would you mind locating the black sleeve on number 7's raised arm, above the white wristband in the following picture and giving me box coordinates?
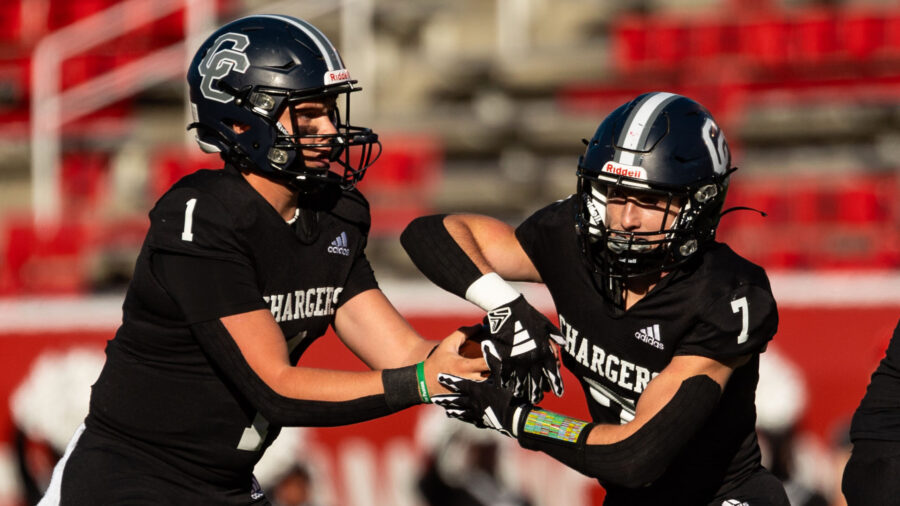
[400,214,481,298]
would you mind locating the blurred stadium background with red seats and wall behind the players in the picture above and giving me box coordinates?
[0,0,900,505]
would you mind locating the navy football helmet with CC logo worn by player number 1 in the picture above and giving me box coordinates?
[187,15,381,189]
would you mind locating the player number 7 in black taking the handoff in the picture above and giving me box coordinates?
[401,92,788,506]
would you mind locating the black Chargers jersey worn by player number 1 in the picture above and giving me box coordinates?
[86,167,377,486]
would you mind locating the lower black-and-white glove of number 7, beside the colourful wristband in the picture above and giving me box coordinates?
[431,373,532,437]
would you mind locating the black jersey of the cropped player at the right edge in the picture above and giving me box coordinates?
[850,321,900,441]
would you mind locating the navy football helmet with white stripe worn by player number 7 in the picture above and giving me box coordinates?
[577,92,736,280]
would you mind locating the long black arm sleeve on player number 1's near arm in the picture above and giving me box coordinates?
[191,320,419,427]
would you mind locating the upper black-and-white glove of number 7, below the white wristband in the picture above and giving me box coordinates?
[481,295,565,404]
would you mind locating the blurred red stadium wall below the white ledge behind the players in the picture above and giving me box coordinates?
[0,304,900,504]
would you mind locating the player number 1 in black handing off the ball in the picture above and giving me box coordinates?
[42,15,487,505]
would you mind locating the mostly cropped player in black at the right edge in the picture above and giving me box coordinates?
[841,321,900,506]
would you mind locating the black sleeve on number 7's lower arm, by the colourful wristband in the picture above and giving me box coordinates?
[519,375,721,488]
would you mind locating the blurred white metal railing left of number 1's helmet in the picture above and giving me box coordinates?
[31,0,215,229]
